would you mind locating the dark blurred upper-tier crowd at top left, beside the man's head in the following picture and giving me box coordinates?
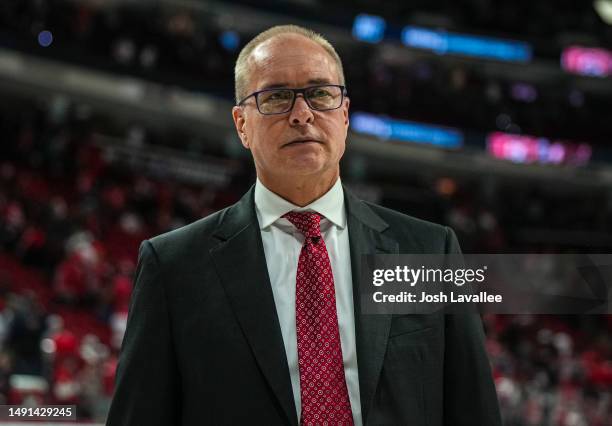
[0,0,240,96]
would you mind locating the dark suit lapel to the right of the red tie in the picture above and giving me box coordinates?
[344,188,399,425]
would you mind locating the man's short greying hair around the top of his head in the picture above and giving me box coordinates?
[234,25,345,103]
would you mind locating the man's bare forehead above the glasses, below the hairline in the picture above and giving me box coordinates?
[250,34,339,90]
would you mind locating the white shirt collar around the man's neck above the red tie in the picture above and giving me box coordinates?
[255,177,346,229]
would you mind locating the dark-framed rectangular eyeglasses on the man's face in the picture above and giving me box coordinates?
[238,84,347,115]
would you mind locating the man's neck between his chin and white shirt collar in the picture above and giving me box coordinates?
[257,170,340,207]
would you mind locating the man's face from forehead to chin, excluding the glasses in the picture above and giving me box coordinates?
[232,34,349,185]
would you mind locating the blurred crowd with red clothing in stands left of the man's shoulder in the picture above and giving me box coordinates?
[0,93,238,420]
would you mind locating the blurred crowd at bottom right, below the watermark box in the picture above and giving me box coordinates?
[484,314,612,426]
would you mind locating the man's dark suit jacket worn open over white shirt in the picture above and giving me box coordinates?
[107,187,501,426]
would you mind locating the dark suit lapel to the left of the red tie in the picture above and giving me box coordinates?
[210,187,298,426]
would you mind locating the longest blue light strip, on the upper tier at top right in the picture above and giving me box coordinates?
[402,26,533,62]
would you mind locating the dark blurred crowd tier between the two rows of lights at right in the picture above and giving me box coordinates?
[344,55,612,148]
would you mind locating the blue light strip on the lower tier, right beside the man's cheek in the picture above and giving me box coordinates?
[351,112,463,148]
